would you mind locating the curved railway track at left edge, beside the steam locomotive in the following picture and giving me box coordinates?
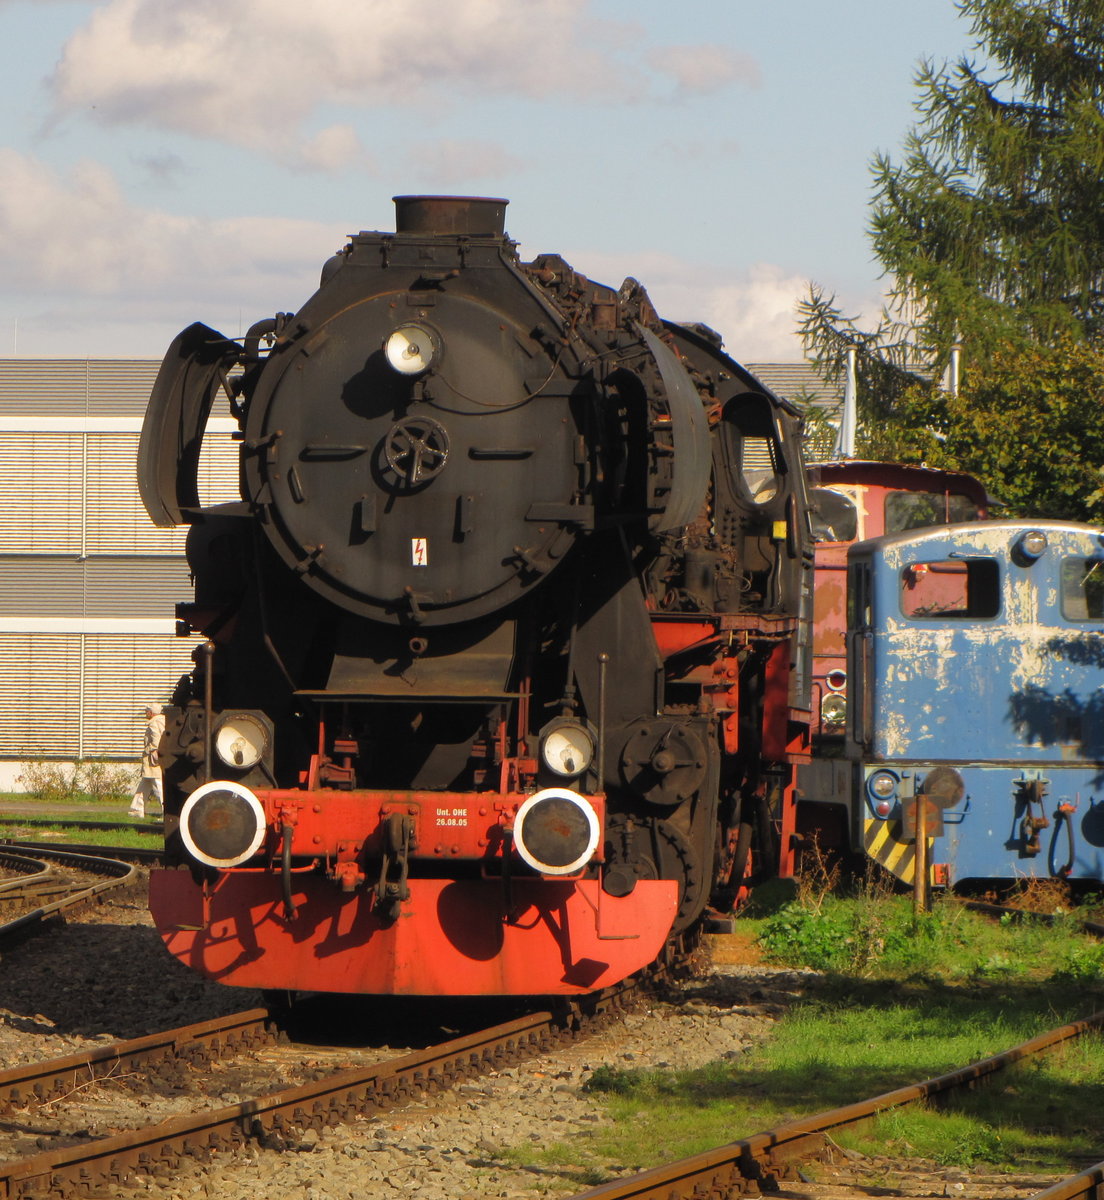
[0,842,138,947]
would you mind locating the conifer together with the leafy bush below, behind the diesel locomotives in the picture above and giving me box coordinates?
[800,0,1104,521]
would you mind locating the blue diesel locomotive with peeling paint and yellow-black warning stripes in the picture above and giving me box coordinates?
[823,521,1104,886]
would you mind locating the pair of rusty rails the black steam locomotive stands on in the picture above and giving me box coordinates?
[0,980,650,1200]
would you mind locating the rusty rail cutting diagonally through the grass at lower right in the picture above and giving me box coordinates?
[564,1012,1104,1200]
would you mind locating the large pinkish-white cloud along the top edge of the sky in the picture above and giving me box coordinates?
[52,0,751,154]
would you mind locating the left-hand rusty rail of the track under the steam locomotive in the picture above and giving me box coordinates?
[0,1008,275,1112]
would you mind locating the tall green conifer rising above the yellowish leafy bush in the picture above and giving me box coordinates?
[871,0,1104,356]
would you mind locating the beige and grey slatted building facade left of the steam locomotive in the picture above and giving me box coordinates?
[0,359,238,760]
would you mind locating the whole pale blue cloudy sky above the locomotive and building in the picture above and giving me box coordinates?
[0,0,971,362]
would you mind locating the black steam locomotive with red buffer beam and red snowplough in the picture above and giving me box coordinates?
[139,197,811,995]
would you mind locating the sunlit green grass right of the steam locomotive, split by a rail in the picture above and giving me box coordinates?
[502,892,1104,1190]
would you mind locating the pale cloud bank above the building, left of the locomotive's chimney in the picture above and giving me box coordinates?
[0,148,343,354]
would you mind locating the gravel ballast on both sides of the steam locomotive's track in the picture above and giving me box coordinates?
[0,873,811,1200]
